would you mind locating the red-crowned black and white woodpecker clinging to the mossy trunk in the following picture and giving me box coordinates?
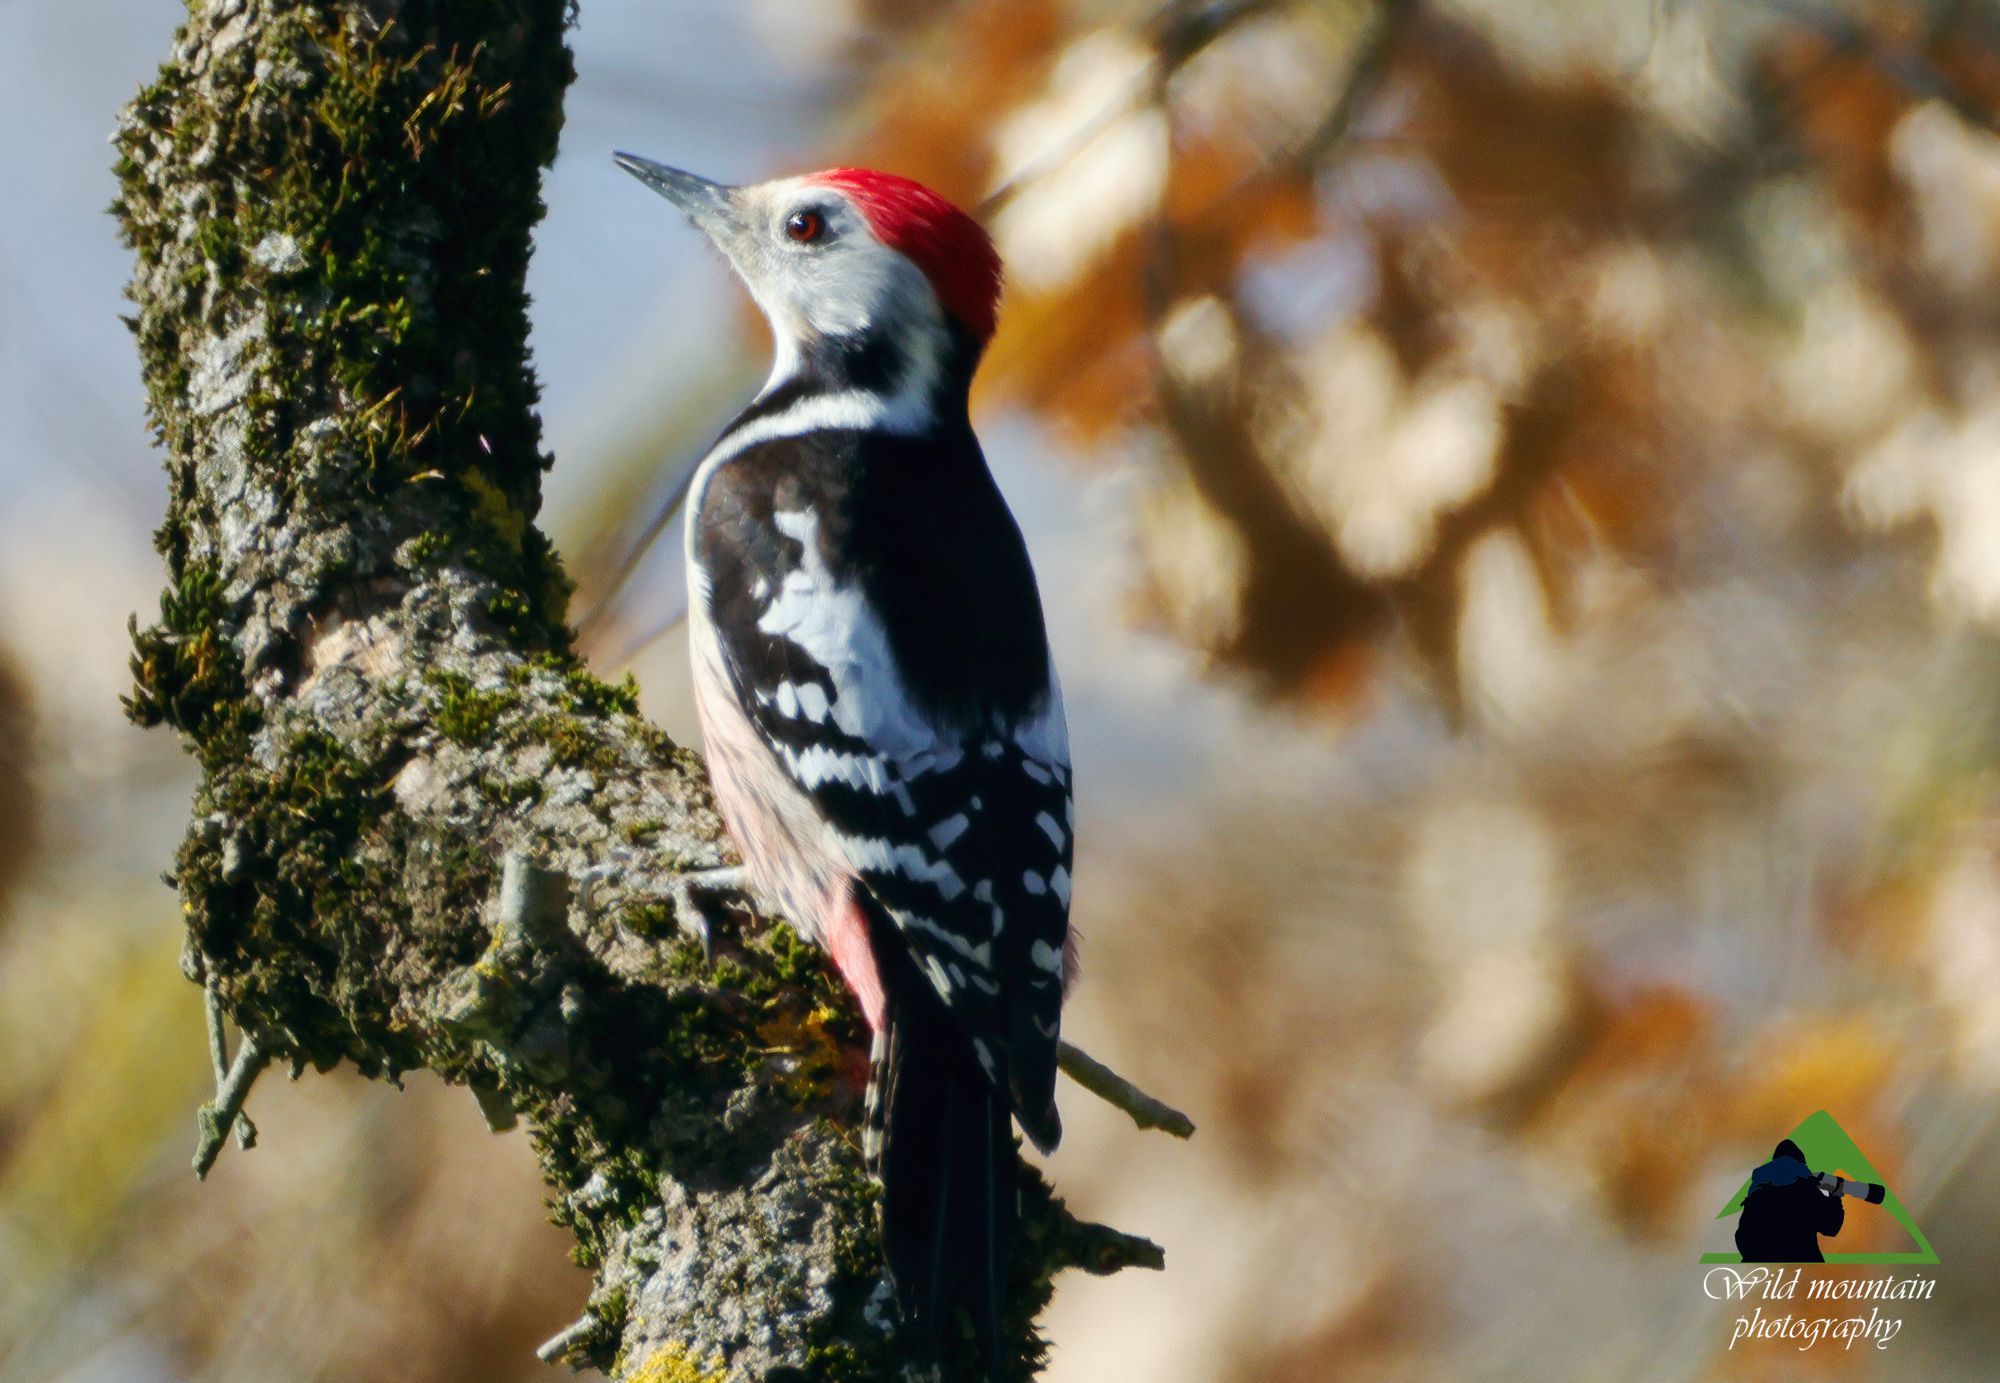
[616,154,1076,1379]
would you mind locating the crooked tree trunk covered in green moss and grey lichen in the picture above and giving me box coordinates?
[116,0,1156,1383]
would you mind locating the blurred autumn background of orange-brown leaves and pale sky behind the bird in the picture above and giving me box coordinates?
[0,0,2000,1383]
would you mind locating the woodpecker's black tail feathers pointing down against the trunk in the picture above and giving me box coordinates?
[870,991,1020,1383]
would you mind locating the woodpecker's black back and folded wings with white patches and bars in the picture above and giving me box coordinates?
[692,428,1074,1147]
